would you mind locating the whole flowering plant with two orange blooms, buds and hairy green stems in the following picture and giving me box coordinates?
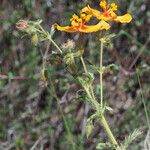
[16,0,142,150]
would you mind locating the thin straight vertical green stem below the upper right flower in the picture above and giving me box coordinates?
[100,41,103,108]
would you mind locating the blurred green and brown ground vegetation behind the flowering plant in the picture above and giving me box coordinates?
[0,0,150,150]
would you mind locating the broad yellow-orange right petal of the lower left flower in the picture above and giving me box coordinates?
[79,20,110,33]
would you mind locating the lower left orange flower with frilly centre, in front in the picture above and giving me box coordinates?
[54,13,110,33]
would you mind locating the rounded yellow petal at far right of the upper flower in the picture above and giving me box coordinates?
[114,14,132,23]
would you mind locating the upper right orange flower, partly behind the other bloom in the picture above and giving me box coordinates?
[81,0,132,23]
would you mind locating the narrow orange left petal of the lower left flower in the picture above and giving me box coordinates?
[53,24,78,32]
